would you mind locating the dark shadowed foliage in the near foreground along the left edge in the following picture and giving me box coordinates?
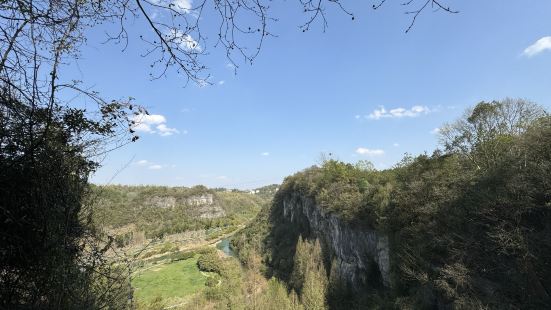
[0,83,135,309]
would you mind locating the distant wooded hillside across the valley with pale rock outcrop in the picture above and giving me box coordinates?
[92,185,269,243]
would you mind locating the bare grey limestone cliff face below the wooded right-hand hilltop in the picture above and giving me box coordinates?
[283,194,391,287]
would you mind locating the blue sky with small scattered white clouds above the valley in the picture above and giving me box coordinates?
[77,0,551,188]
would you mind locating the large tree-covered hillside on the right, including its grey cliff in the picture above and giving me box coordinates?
[233,99,551,309]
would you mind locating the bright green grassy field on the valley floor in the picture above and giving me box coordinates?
[132,257,207,303]
